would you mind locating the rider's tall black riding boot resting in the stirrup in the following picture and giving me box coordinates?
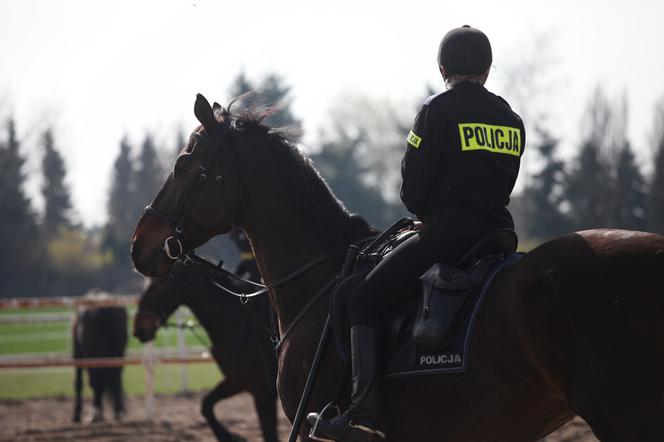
[307,325,385,442]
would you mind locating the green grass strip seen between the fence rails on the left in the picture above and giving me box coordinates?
[0,308,221,399]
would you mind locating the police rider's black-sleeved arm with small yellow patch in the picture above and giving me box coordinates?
[401,103,443,219]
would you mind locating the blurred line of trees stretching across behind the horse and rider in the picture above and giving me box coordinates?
[0,73,664,297]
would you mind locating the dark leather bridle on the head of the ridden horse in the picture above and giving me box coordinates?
[143,117,231,261]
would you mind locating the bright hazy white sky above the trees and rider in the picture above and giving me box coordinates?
[0,0,664,225]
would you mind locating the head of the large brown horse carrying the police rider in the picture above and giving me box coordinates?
[131,94,240,276]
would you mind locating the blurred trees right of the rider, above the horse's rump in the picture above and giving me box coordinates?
[519,87,664,241]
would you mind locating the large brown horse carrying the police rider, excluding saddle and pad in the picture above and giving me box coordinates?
[131,94,664,442]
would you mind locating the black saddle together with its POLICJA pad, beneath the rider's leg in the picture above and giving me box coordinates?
[331,219,520,378]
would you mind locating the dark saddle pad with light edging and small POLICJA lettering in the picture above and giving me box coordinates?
[384,254,523,379]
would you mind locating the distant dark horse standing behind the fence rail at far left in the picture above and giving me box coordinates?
[72,307,127,422]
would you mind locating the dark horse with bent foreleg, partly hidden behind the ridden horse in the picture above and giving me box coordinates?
[134,261,279,442]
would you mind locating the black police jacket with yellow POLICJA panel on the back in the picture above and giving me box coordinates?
[401,83,526,235]
